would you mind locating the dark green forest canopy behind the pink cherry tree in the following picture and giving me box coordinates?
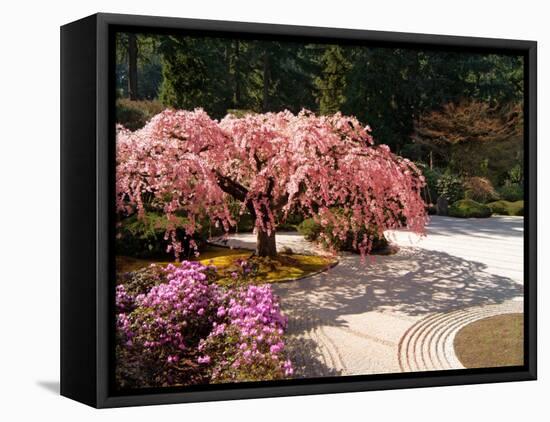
[117,33,523,159]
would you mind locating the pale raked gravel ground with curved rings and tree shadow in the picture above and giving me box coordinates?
[211,216,523,377]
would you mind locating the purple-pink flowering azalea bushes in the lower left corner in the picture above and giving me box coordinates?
[116,261,292,387]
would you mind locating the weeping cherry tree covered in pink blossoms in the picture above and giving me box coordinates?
[116,109,427,257]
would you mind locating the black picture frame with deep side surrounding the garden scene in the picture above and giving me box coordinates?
[61,13,537,408]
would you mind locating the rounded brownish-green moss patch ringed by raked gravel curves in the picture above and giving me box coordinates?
[454,314,524,368]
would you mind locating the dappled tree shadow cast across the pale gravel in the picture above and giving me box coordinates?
[274,247,523,330]
